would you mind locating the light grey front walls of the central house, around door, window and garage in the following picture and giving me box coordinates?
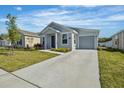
[41,32,98,50]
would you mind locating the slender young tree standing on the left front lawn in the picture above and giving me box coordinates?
[6,14,20,54]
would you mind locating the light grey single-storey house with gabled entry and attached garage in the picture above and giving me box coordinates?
[40,22,99,49]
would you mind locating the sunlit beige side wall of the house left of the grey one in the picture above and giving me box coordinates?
[23,36,40,47]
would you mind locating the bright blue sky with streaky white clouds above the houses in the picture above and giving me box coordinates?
[0,5,124,37]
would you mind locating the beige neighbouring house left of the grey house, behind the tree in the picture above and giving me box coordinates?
[17,30,40,48]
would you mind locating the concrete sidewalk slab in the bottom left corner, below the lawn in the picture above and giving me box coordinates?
[0,69,36,88]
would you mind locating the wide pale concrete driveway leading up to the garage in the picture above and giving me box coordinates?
[13,50,100,88]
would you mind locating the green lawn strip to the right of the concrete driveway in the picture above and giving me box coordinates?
[98,50,124,88]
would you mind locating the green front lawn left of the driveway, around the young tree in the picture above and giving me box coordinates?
[0,49,57,72]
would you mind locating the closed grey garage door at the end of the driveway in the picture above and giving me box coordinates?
[79,36,95,49]
